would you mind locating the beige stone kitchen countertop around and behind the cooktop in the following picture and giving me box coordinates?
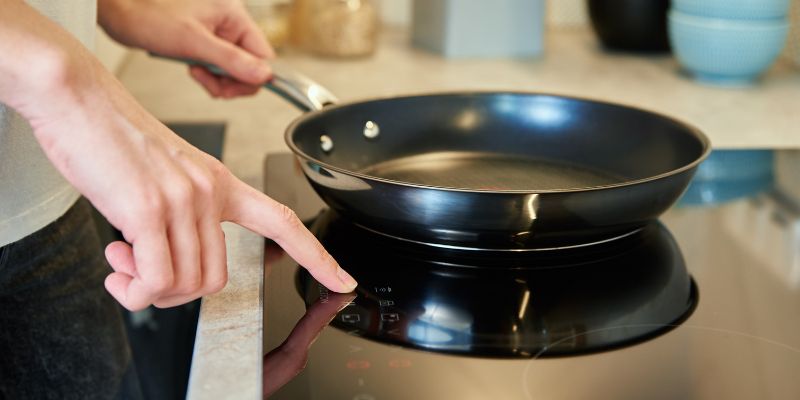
[114,29,800,399]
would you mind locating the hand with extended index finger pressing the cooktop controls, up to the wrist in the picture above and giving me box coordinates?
[55,69,354,309]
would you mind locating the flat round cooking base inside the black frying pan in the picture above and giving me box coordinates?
[359,152,626,191]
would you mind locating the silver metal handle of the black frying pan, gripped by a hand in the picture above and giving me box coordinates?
[150,53,339,111]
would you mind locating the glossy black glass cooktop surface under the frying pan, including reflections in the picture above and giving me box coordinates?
[263,151,800,400]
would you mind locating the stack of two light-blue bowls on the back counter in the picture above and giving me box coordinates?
[668,0,789,86]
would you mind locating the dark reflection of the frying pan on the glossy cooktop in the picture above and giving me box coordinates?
[298,214,698,357]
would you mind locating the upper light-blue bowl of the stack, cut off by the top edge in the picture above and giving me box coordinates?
[672,0,789,19]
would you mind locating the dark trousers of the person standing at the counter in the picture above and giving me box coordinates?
[0,199,141,399]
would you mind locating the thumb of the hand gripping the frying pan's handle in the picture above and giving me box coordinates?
[192,30,272,85]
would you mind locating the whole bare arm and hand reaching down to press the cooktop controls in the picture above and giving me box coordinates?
[0,0,355,310]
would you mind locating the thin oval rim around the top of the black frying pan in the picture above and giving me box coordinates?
[284,90,712,194]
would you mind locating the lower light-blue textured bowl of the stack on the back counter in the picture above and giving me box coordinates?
[668,10,789,86]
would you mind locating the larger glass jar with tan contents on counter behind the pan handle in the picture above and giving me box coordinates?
[305,0,380,57]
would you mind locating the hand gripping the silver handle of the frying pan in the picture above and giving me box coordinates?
[98,0,275,98]
